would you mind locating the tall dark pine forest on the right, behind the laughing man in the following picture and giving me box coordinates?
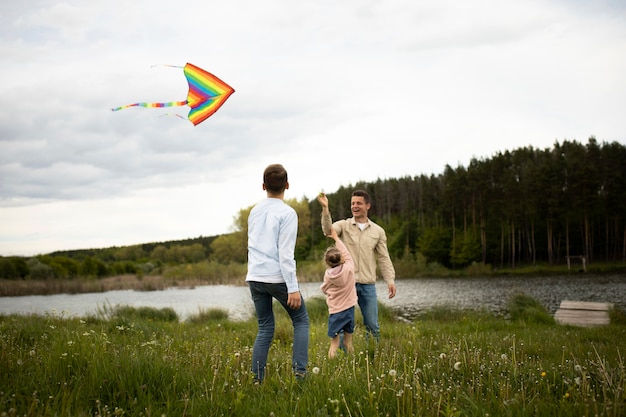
[316,137,626,268]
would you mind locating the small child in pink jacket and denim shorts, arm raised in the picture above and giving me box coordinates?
[320,208,357,359]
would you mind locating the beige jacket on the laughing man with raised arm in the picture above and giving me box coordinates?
[322,211,396,284]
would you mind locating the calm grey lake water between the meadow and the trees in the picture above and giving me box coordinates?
[0,274,626,319]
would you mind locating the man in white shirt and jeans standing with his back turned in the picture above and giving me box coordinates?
[246,164,309,384]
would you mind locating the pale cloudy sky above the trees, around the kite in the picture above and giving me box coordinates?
[0,0,626,256]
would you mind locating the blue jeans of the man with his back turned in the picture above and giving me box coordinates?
[248,281,309,381]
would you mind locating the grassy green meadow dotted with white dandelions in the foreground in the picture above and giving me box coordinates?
[0,294,626,417]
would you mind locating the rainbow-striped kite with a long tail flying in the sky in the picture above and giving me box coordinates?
[111,63,235,126]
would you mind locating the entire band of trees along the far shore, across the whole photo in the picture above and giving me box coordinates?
[0,137,626,279]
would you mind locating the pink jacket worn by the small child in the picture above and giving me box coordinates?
[320,240,357,314]
